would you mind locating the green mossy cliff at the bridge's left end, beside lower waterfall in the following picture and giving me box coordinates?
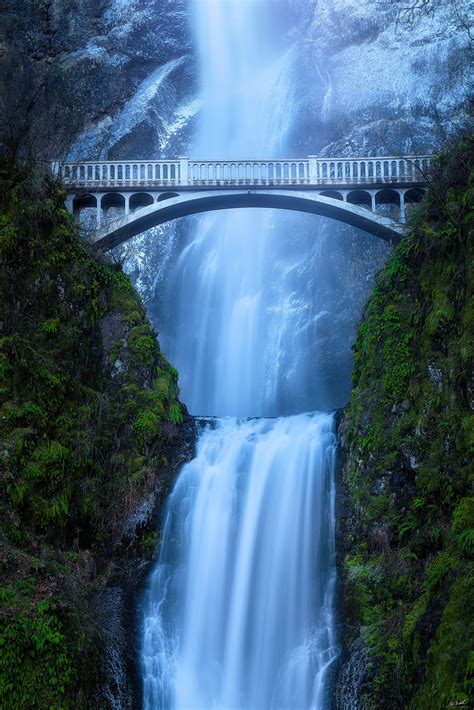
[0,164,183,710]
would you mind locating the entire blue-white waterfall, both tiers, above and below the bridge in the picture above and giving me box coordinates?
[141,0,337,710]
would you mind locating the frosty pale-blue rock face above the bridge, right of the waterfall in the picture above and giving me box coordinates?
[286,0,470,155]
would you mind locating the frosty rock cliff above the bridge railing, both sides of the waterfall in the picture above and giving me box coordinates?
[0,0,469,159]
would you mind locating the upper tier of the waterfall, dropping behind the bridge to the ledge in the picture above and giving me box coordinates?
[159,0,318,416]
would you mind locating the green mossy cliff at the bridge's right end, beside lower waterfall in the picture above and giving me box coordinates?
[338,140,474,710]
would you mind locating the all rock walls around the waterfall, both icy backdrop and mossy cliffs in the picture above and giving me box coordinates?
[0,0,473,710]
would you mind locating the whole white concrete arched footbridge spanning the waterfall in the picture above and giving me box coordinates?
[52,156,431,250]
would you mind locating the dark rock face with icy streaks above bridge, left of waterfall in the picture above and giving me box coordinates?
[0,0,197,159]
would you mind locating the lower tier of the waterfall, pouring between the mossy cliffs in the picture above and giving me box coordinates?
[141,413,337,710]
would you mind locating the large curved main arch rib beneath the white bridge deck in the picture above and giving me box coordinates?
[93,189,403,250]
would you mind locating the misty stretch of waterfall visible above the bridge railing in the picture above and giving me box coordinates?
[191,0,292,158]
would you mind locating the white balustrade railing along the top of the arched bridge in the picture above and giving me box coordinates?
[52,155,431,189]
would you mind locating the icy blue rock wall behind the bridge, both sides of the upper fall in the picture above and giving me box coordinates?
[0,0,469,407]
